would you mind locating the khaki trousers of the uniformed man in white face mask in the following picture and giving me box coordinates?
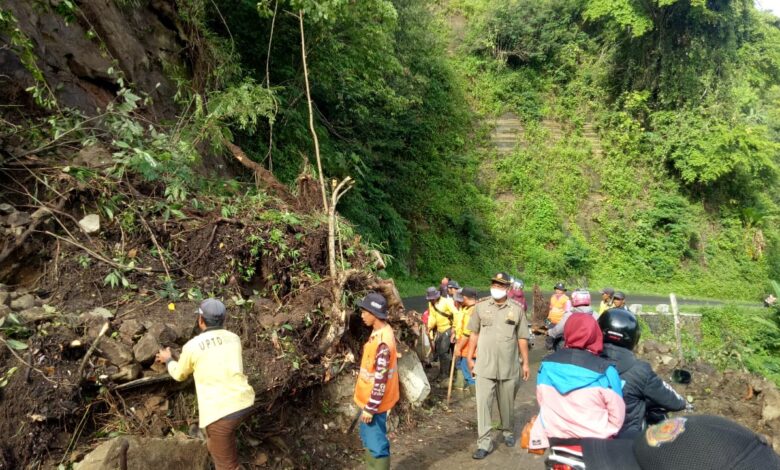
[477,375,517,452]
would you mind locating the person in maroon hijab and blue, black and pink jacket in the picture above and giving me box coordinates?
[529,313,626,449]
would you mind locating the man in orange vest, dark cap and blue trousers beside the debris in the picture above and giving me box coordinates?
[355,292,400,470]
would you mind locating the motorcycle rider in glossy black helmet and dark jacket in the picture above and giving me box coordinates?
[598,308,691,438]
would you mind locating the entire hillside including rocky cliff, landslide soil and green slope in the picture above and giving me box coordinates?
[0,0,780,469]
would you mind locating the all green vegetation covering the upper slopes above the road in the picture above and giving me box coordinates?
[0,0,780,299]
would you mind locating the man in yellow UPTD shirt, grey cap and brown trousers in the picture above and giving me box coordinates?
[157,299,255,470]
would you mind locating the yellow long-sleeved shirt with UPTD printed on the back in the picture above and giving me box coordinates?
[168,328,255,428]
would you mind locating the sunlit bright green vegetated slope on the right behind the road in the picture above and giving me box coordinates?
[442,0,780,299]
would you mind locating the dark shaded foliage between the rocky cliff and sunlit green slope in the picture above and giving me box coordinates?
[201,0,494,282]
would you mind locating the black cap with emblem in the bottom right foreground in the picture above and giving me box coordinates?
[582,415,780,470]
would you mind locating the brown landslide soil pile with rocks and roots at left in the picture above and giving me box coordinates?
[0,149,414,469]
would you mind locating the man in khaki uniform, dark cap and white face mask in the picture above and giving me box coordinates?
[466,273,530,460]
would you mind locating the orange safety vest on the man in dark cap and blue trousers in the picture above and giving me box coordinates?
[355,325,400,413]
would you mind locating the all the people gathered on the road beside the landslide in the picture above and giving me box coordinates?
[152,273,780,470]
